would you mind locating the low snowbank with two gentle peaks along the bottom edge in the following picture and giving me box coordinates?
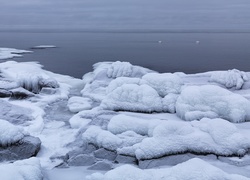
[87,158,249,180]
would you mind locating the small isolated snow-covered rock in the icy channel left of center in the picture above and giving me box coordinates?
[67,96,92,113]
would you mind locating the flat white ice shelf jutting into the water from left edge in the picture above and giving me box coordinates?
[0,48,32,60]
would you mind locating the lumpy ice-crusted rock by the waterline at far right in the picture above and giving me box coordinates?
[209,69,248,90]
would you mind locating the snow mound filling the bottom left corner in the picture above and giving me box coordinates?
[0,158,43,180]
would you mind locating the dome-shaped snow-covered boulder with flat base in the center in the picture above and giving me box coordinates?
[101,84,162,113]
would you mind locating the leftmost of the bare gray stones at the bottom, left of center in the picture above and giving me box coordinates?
[68,154,96,166]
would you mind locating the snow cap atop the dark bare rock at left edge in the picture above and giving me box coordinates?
[0,119,25,146]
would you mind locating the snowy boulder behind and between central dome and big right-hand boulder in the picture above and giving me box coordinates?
[142,73,183,97]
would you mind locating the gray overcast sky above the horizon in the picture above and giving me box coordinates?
[0,0,250,30]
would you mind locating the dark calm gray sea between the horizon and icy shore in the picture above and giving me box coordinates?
[0,32,250,77]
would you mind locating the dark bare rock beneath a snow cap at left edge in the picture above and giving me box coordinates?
[0,136,41,162]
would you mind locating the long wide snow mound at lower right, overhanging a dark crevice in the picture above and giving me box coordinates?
[118,118,249,160]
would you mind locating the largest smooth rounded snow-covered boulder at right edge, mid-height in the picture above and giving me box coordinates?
[176,85,250,122]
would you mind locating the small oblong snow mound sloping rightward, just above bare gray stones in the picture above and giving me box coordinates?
[82,126,122,150]
